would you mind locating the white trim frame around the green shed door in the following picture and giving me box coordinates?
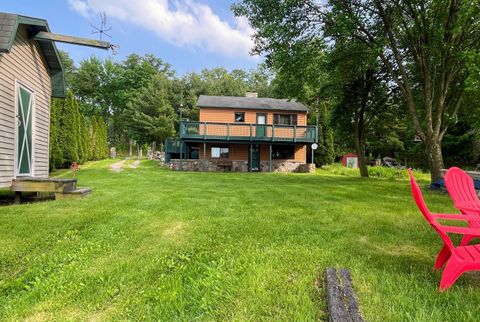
[13,78,36,179]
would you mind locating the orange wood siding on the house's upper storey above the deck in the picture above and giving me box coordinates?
[200,107,307,125]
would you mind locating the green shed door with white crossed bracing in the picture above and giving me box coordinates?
[15,84,33,176]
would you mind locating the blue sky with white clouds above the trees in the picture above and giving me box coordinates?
[0,0,261,74]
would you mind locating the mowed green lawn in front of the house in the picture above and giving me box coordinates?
[0,161,480,321]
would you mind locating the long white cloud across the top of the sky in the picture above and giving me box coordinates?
[69,0,253,57]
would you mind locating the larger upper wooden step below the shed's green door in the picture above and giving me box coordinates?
[11,177,77,193]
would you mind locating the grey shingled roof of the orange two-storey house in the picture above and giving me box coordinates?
[197,95,308,112]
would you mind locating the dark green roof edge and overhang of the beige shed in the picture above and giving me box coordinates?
[0,12,66,97]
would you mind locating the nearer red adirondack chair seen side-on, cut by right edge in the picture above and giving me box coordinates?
[408,169,480,291]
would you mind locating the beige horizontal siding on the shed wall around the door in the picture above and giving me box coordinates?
[0,25,51,187]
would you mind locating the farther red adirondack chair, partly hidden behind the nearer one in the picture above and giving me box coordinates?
[444,167,480,246]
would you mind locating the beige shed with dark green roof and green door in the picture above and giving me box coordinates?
[0,13,65,187]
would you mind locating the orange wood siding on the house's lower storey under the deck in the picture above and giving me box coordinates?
[199,143,307,163]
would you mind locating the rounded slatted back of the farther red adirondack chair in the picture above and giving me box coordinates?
[445,167,478,204]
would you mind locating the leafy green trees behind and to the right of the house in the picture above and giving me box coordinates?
[54,9,480,180]
